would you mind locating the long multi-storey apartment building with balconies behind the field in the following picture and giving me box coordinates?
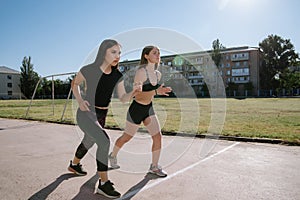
[120,46,261,96]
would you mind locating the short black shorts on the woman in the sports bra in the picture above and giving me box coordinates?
[127,100,155,124]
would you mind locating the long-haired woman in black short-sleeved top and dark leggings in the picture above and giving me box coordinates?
[68,39,141,198]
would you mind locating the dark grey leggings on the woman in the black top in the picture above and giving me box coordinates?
[75,109,110,171]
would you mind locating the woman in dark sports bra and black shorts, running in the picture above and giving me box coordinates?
[109,46,172,177]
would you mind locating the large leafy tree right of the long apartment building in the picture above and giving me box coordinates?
[259,35,299,89]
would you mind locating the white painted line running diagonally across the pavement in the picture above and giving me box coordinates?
[120,142,240,199]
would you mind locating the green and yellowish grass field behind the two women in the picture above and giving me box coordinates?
[0,98,300,144]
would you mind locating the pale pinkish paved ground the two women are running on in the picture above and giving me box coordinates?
[0,119,300,200]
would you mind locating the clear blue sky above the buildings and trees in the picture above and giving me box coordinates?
[0,0,300,76]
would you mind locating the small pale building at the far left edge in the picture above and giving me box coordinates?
[0,66,21,99]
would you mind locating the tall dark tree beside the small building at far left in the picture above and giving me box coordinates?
[20,56,39,98]
